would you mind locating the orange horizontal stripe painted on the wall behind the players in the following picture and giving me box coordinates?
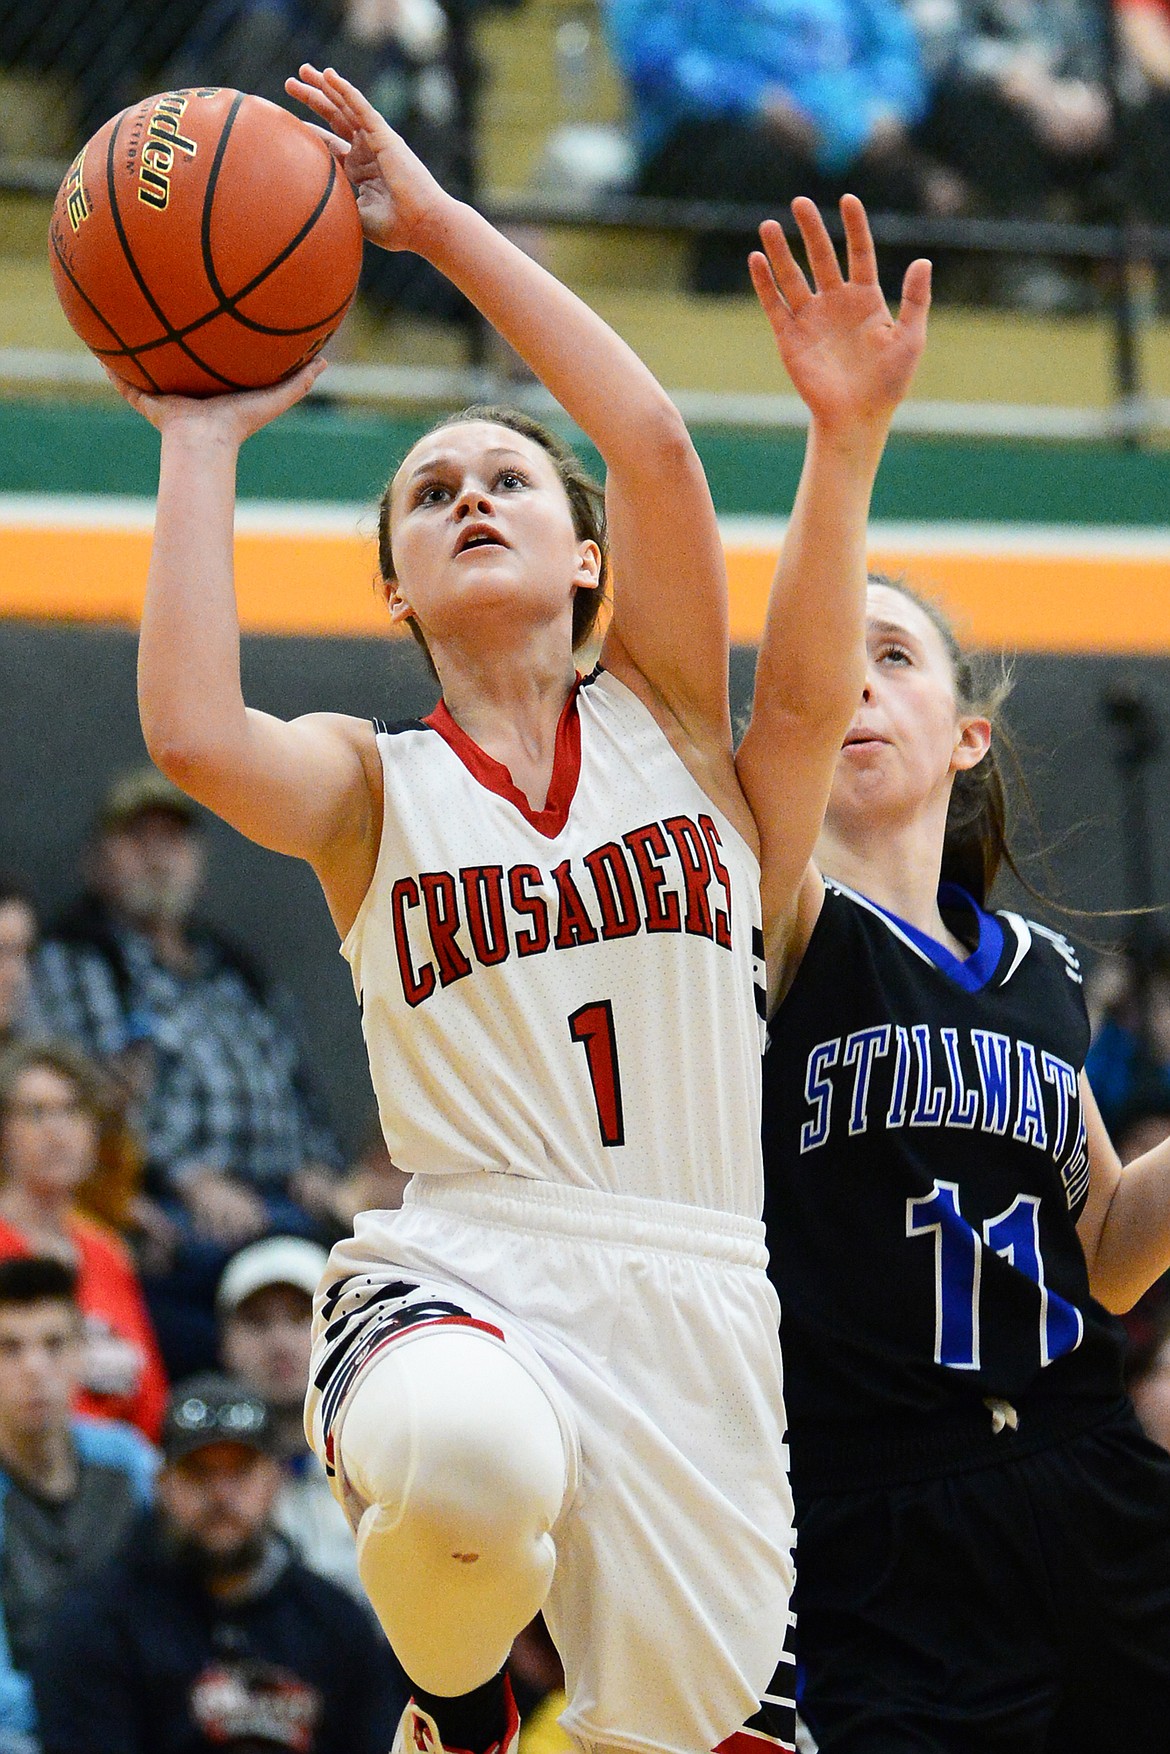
[0,524,1170,654]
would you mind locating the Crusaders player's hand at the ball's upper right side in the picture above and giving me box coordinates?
[284,61,451,256]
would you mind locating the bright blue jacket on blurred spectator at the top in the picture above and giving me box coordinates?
[603,0,926,172]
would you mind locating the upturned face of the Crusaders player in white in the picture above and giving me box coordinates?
[389,421,600,651]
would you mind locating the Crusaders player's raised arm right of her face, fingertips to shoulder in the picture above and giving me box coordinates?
[288,67,733,764]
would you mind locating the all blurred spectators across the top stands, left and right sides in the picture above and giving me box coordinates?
[0,0,1170,321]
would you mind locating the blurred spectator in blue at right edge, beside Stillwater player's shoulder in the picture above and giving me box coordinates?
[1084,938,1170,1138]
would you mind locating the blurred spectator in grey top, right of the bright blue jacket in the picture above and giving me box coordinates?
[907,0,1110,307]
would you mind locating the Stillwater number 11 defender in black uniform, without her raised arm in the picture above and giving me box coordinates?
[749,582,1170,1754]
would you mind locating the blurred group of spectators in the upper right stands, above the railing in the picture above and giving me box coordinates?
[603,0,1170,305]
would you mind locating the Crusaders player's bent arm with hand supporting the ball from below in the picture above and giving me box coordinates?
[114,361,379,924]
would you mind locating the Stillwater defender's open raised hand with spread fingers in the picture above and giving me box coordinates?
[749,195,930,438]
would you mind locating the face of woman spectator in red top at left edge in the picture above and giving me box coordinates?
[0,1065,98,1203]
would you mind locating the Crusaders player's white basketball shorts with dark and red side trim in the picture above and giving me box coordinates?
[305,1173,793,1754]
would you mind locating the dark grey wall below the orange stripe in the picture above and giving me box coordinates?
[0,623,1170,1147]
